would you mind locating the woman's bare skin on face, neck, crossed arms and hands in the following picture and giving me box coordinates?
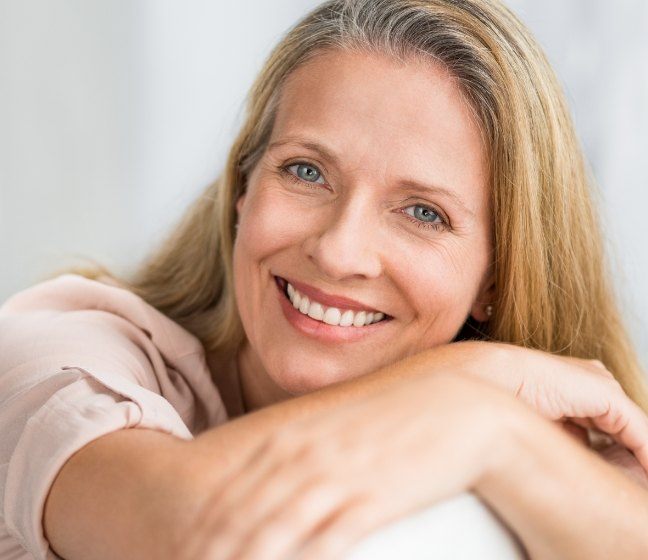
[38,53,648,560]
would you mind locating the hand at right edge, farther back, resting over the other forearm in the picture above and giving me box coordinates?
[454,342,648,472]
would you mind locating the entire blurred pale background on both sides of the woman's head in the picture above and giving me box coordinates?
[0,0,648,365]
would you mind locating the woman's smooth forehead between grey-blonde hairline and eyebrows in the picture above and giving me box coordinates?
[270,51,486,209]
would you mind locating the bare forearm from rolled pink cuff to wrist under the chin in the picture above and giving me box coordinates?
[43,343,477,560]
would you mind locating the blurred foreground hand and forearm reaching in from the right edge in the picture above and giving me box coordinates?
[189,372,648,560]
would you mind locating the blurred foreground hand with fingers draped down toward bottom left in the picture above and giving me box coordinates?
[175,373,524,560]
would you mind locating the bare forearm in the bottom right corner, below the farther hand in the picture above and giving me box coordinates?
[476,403,648,560]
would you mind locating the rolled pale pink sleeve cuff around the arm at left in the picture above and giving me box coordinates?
[4,366,193,560]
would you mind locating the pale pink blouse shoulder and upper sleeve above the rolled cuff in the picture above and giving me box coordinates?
[0,274,230,430]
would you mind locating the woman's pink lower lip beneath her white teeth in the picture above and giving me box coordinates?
[274,277,391,342]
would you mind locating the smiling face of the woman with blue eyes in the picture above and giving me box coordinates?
[234,51,492,395]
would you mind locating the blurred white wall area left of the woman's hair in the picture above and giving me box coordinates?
[0,0,315,301]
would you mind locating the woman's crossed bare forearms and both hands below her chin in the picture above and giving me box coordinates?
[43,342,648,560]
